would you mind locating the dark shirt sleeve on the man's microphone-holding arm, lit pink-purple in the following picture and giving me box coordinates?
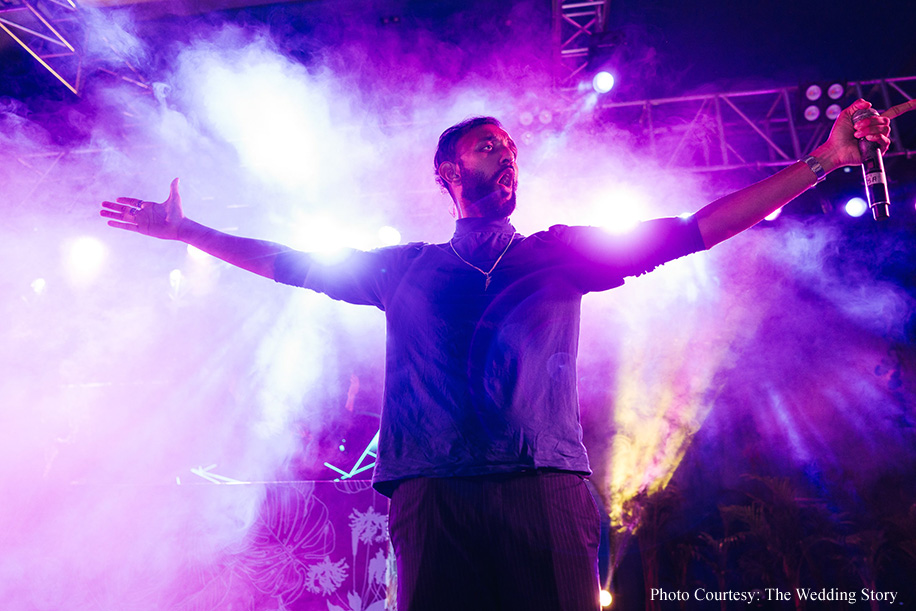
[550,216,706,291]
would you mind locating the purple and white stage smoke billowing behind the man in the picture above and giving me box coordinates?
[0,2,913,609]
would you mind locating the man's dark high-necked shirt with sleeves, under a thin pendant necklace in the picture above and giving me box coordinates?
[275,218,704,495]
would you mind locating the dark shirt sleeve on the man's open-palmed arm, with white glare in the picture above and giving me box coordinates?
[274,245,416,310]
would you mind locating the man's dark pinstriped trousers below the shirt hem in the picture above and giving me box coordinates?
[388,472,599,611]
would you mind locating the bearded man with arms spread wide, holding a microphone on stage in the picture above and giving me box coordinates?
[102,100,899,610]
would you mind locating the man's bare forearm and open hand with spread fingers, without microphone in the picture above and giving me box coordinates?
[101,178,285,279]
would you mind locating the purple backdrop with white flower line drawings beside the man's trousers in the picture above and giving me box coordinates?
[164,480,394,611]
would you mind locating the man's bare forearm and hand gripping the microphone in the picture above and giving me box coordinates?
[696,100,900,248]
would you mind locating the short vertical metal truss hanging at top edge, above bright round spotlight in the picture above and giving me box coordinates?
[552,0,611,89]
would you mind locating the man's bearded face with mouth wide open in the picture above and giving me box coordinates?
[455,125,518,218]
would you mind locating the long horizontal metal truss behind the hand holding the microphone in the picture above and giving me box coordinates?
[598,76,916,171]
